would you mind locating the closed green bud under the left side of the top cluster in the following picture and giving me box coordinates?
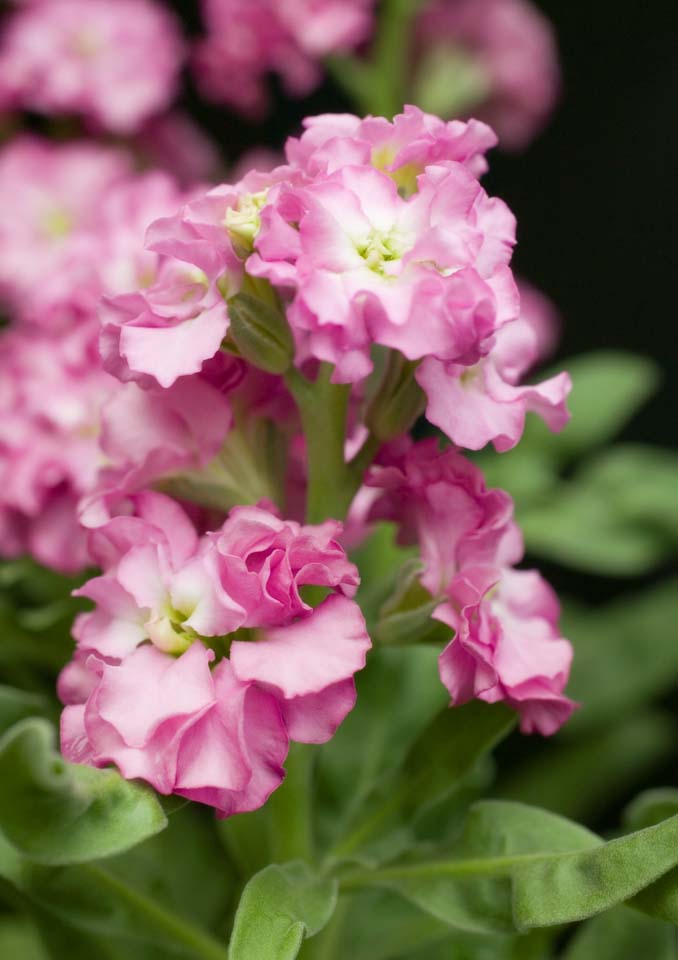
[228,293,294,374]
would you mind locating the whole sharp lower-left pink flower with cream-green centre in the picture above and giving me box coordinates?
[60,493,370,816]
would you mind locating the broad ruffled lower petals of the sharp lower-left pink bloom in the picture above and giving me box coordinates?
[61,643,289,817]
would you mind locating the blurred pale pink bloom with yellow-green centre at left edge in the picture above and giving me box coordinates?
[0,136,131,327]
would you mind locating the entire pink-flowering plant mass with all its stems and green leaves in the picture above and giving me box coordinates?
[0,0,678,960]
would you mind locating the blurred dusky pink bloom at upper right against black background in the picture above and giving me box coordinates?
[417,0,560,150]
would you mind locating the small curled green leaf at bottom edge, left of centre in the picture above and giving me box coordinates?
[228,862,337,960]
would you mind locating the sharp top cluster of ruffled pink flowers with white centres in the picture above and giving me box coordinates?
[103,107,570,450]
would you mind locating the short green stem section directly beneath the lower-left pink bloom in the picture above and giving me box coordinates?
[268,743,315,863]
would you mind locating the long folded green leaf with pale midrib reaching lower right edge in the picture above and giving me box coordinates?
[343,801,678,933]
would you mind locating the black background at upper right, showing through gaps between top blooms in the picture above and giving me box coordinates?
[174,0,678,450]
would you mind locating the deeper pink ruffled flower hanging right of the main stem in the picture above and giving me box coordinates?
[368,441,575,735]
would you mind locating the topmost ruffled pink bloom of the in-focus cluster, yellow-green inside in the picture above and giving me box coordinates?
[285,106,497,184]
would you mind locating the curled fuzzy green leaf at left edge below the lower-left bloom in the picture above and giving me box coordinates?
[0,719,167,864]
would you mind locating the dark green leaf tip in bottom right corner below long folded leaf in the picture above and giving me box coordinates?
[563,907,676,960]
